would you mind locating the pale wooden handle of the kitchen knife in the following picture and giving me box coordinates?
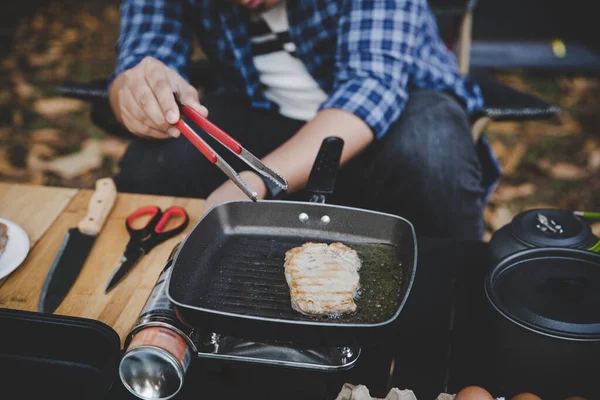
[77,178,117,236]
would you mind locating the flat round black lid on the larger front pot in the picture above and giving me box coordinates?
[486,248,600,340]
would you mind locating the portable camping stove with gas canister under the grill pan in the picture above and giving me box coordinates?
[119,250,361,399]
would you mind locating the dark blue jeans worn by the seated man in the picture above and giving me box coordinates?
[115,90,485,239]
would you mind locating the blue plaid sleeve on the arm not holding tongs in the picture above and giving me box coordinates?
[321,0,427,138]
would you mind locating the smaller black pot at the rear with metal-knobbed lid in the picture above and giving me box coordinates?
[490,208,600,262]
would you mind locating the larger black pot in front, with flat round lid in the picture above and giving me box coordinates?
[485,248,600,400]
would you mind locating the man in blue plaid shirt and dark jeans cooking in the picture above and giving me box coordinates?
[109,0,492,239]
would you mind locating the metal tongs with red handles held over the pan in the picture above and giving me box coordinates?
[175,96,288,201]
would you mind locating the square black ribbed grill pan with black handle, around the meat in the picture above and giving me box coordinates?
[169,139,416,347]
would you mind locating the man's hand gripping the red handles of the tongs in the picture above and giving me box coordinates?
[109,57,208,139]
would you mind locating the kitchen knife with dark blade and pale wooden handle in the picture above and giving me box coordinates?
[38,178,117,314]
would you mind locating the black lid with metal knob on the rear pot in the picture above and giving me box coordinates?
[512,209,595,247]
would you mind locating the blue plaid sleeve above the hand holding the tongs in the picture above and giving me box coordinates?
[110,0,192,81]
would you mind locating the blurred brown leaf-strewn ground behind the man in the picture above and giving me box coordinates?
[0,0,600,237]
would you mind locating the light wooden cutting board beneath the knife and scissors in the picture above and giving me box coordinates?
[0,185,204,341]
